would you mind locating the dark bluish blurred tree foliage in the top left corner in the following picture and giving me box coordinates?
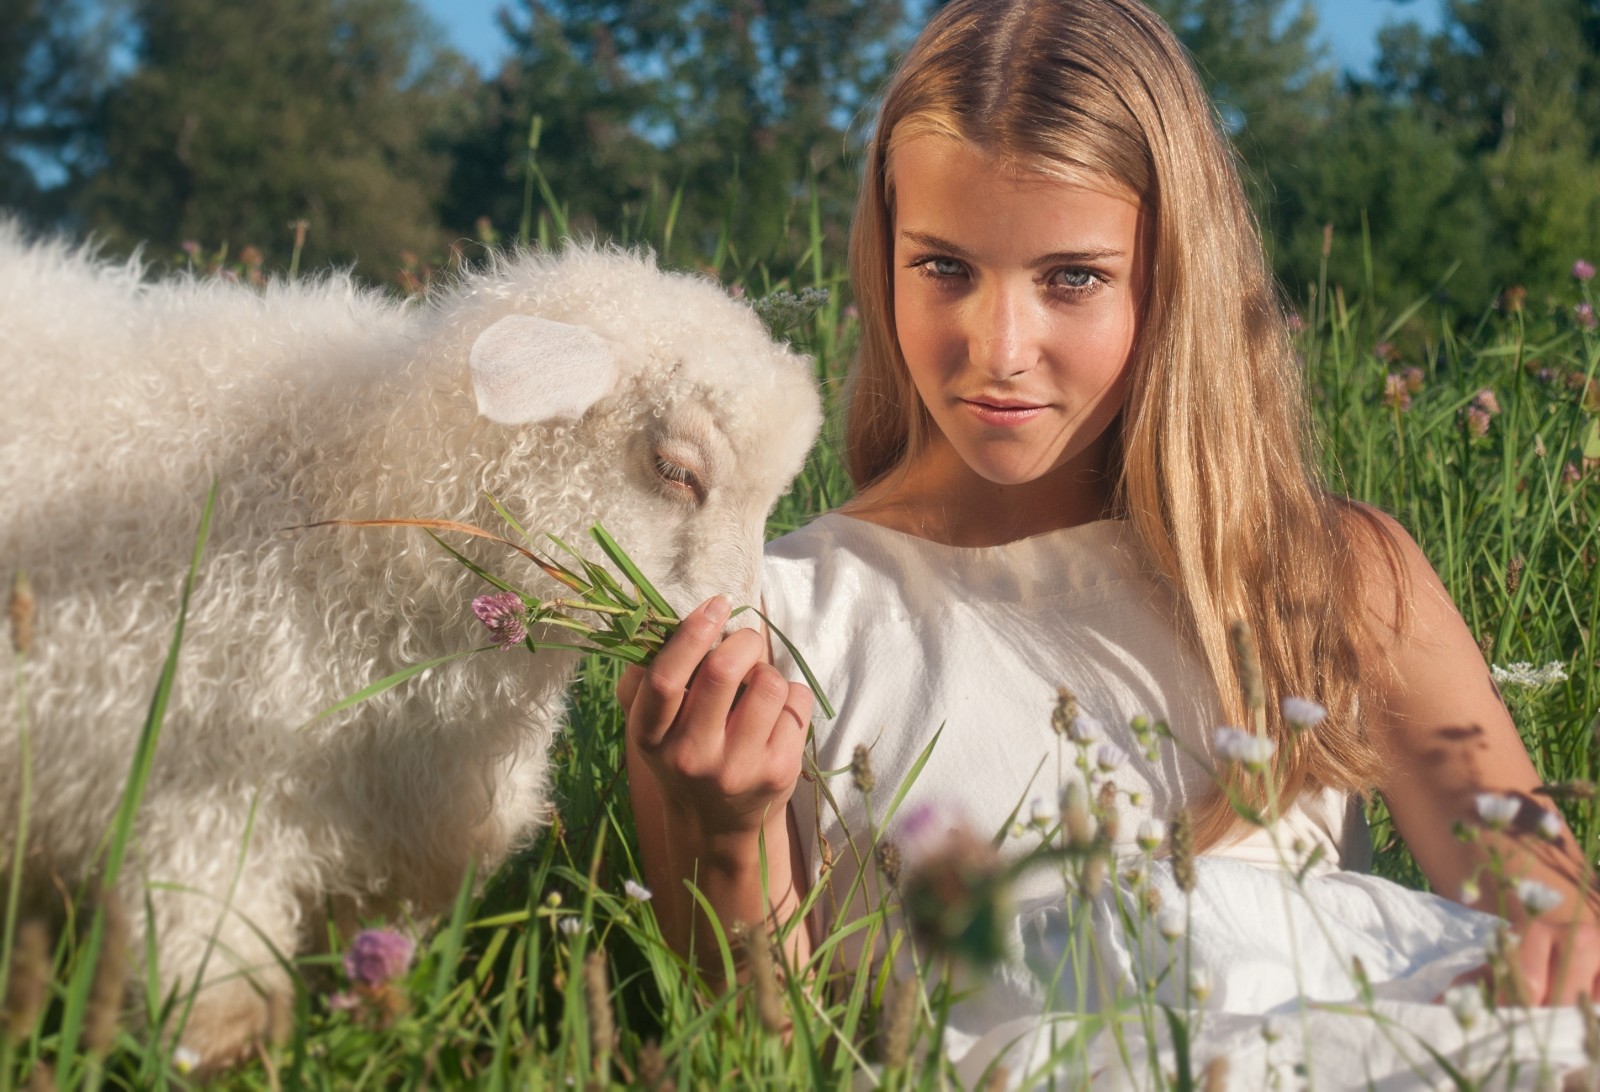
[0,0,110,223]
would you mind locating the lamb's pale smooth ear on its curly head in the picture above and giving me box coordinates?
[470,315,619,424]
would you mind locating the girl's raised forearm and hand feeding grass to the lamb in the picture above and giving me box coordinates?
[618,597,811,974]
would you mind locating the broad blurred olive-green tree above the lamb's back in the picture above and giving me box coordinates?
[83,0,470,275]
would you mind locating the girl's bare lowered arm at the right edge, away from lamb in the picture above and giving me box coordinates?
[1366,516,1600,1004]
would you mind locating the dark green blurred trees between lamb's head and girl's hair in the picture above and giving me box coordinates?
[451,0,910,267]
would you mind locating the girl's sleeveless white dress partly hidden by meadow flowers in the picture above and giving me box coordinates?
[763,514,1584,1089]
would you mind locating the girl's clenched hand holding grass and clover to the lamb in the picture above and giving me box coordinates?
[618,596,813,850]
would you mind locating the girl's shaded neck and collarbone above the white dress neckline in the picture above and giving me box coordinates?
[842,425,1112,546]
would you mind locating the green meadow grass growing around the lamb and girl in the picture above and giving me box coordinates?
[0,222,1600,1092]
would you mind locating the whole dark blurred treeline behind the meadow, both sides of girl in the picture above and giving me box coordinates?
[0,0,1600,312]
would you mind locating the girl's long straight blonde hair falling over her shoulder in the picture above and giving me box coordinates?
[845,0,1387,847]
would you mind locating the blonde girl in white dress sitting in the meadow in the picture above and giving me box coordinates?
[621,0,1600,1087]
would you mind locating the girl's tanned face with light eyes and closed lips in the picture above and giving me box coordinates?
[893,134,1147,487]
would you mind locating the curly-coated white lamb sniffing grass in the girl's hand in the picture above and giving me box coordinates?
[0,223,821,1065]
